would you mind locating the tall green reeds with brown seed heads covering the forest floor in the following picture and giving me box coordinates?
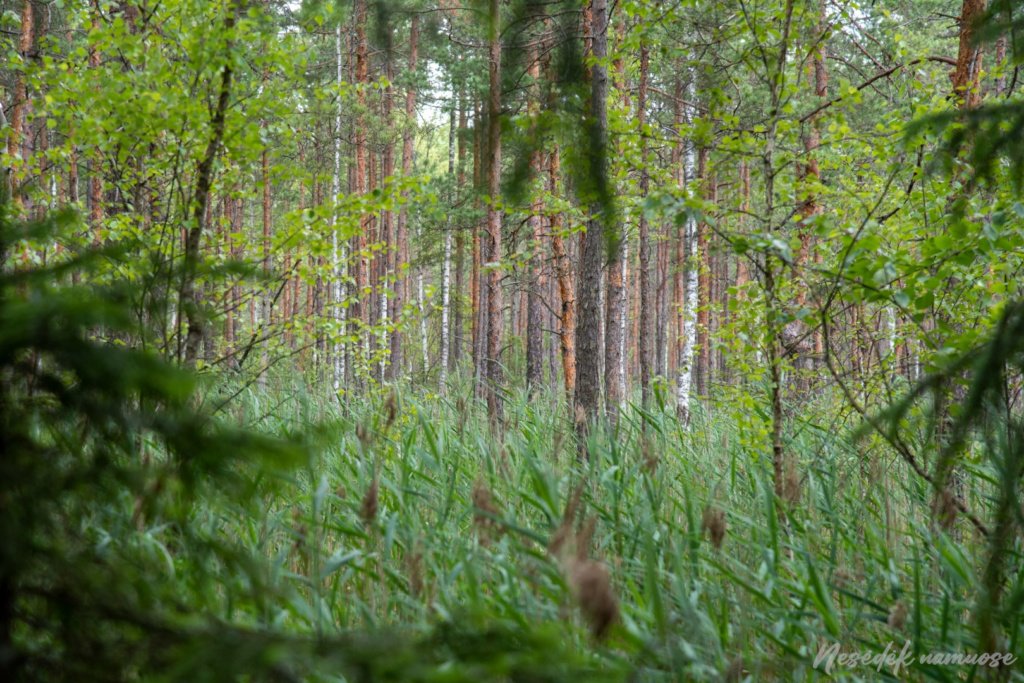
[188,370,1024,681]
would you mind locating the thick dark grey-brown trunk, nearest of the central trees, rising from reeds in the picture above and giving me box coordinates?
[574,0,608,444]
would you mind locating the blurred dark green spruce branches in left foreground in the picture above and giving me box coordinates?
[0,206,614,681]
